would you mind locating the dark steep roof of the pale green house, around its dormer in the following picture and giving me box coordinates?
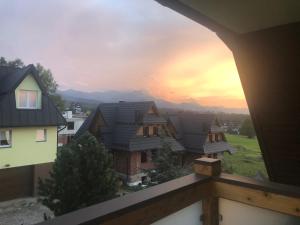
[0,65,66,127]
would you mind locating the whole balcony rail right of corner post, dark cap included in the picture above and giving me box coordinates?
[213,174,300,217]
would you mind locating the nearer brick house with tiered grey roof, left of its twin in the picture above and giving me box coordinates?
[76,101,184,184]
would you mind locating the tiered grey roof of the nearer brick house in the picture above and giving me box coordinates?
[76,101,183,151]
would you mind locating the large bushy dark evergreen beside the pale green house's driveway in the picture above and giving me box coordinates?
[39,133,117,215]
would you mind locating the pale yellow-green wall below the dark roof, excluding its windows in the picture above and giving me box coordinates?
[0,127,57,169]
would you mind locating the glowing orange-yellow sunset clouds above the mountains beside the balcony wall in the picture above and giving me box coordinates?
[149,43,247,108]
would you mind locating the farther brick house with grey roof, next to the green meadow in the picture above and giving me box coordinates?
[167,111,235,163]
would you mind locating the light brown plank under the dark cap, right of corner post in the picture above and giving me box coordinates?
[213,182,300,217]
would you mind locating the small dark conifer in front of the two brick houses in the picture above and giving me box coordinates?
[145,140,190,184]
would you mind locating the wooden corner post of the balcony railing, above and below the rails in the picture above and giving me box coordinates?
[194,158,221,225]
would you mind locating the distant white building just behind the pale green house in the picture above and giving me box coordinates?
[58,111,87,146]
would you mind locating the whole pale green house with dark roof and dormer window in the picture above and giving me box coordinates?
[0,65,65,200]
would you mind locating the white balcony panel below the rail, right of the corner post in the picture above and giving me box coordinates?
[219,199,300,225]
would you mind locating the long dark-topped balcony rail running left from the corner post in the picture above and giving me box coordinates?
[36,174,212,225]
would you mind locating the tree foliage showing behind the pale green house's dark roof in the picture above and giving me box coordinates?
[0,57,65,111]
